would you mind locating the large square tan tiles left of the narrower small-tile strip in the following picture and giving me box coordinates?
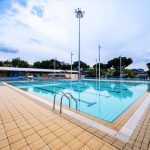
[0,86,116,150]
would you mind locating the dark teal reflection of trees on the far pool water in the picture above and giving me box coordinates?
[22,81,150,99]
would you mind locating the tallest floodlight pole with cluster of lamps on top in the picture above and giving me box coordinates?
[75,8,85,79]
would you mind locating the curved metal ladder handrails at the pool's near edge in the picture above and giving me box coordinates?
[53,91,77,113]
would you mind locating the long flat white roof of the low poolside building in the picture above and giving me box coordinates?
[0,67,77,73]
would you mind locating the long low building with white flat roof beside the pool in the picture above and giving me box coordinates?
[0,67,78,80]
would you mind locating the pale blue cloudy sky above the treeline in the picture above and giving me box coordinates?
[0,0,150,69]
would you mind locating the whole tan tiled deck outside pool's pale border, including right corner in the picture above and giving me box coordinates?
[0,86,150,150]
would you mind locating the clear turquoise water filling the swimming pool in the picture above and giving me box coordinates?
[9,80,149,122]
